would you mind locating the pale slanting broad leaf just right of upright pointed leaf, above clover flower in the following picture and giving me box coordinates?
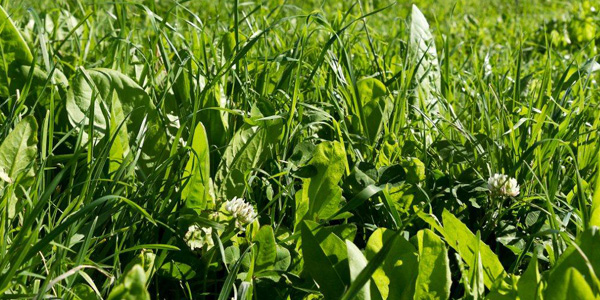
[215,123,281,199]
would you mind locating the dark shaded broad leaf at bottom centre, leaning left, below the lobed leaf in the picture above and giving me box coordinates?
[300,222,346,299]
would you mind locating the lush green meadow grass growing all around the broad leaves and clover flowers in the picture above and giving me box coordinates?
[0,0,600,299]
